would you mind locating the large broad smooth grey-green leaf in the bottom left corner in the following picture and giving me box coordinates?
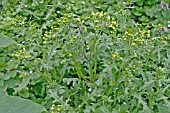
[0,92,46,113]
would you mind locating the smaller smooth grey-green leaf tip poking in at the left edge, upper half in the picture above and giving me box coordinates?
[0,34,15,47]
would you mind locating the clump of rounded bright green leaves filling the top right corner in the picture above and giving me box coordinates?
[130,0,170,26]
